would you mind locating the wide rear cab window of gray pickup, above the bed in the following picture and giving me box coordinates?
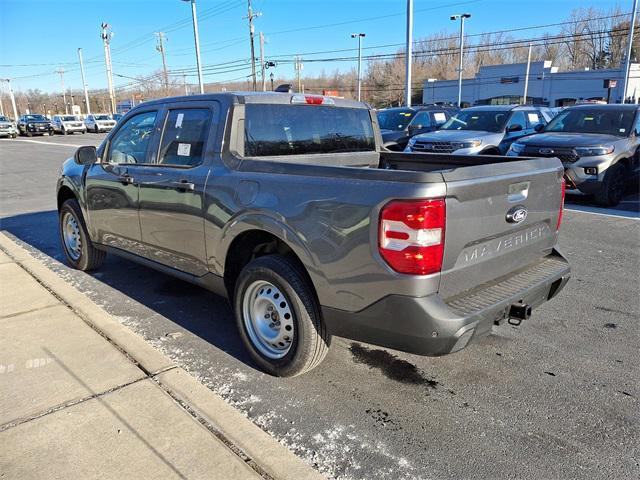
[244,104,375,157]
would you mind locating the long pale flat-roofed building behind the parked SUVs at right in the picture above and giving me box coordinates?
[422,60,640,107]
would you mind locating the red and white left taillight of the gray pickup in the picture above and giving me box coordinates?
[378,198,446,275]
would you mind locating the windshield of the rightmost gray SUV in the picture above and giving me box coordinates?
[544,108,636,137]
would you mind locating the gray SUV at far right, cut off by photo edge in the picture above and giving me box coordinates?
[508,104,640,206]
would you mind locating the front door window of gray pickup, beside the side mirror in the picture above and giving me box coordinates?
[107,112,157,164]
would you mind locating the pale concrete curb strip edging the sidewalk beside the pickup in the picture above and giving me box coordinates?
[0,232,324,480]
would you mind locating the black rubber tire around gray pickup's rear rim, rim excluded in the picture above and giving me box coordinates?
[233,255,331,377]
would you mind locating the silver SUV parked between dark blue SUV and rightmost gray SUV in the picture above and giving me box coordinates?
[405,105,551,155]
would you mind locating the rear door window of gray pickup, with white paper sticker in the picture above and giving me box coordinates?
[158,108,211,167]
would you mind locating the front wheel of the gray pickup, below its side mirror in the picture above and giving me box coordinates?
[58,199,106,272]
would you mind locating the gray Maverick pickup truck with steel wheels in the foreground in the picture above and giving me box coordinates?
[57,93,570,376]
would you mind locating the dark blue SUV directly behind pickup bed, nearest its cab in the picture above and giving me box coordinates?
[376,105,458,151]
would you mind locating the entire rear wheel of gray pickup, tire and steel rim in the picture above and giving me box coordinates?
[234,255,331,377]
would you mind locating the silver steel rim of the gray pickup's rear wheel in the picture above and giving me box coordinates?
[242,280,295,359]
